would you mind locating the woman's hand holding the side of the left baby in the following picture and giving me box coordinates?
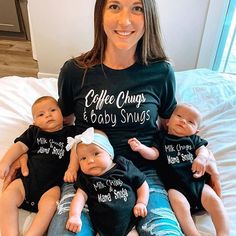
[2,153,29,191]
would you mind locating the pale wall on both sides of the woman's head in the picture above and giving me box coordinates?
[28,0,227,77]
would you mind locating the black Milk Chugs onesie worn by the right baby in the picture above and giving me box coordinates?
[157,132,207,212]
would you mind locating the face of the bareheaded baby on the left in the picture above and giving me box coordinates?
[32,99,63,132]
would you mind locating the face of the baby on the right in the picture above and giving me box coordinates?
[167,106,200,137]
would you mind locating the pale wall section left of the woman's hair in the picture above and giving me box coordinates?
[28,0,95,77]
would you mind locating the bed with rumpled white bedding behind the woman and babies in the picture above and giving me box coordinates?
[0,69,236,236]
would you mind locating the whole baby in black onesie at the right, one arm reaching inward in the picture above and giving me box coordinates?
[128,104,228,235]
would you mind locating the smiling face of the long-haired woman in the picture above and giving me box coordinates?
[103,0,144,52]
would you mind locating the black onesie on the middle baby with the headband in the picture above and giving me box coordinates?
[75,156,146,236]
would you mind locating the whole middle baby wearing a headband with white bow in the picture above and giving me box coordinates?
[66,127,149,236]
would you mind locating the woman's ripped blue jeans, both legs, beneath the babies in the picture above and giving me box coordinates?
[48,170,182,236]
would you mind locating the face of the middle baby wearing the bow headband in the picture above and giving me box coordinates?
[76,143,113,176]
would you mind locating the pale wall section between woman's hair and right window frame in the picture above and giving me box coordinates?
[157,0,209,70]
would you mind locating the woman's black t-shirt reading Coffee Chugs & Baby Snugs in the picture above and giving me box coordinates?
[58,59,176,169]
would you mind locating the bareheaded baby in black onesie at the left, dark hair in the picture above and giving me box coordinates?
[0,96,75,235]
